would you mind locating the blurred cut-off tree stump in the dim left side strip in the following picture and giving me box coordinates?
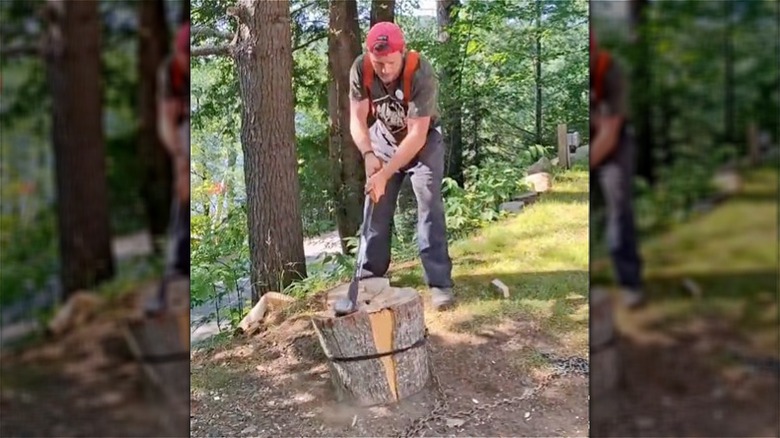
[125,279,190,436]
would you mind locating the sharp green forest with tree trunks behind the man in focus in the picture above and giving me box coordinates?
[192,1,588,323]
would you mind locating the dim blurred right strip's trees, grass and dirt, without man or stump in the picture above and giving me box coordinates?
[591,1,780,437]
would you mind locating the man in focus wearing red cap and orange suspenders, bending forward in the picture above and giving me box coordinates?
[350,22,454,310]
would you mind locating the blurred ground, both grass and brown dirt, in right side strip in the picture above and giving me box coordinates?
[591,168,780,437]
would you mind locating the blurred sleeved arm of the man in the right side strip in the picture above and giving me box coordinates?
[590,61,627,169]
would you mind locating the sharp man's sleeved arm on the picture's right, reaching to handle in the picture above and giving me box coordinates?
[382,59,439,175]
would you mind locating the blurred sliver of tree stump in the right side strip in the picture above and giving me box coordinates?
[590,288,620,422]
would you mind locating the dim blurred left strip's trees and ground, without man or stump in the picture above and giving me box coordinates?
[0,0,189,437]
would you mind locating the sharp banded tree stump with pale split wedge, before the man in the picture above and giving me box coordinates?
[312,278,429,406]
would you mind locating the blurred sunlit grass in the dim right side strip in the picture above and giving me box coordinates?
[600,168,780,356]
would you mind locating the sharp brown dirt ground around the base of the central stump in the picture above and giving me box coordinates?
[191,318,588,437]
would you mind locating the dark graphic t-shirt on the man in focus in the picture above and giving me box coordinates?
[349,55,441,161]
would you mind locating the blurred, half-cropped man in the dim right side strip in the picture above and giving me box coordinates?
[590,31,644,308]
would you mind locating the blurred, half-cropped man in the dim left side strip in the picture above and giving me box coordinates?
[148,21,190,312]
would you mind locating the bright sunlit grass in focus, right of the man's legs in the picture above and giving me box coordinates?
[391,169,589,362]
